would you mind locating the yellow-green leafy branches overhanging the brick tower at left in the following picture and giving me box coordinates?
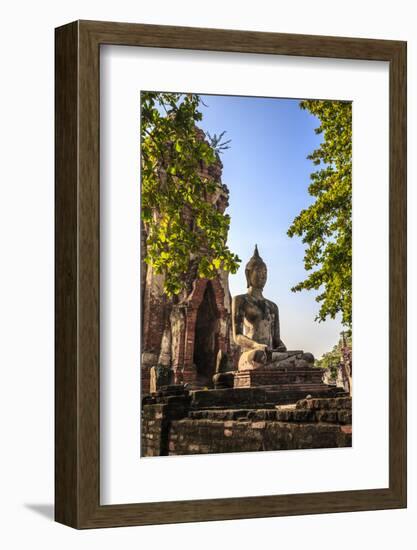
[141,92,240,296]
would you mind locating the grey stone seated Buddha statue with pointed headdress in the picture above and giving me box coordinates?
[232,246,314,371]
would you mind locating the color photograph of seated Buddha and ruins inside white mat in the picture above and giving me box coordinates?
[137,90,352,457]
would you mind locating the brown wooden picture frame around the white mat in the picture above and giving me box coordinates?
[55,21,406,528]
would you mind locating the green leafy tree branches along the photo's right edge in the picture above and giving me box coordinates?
[288,100,352,326]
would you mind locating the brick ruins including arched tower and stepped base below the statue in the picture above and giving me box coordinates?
[141,130,352,456]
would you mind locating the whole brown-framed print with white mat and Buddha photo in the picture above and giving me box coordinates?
[55,21,406,528]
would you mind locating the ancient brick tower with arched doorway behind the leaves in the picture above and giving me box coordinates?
[141,129,231,394]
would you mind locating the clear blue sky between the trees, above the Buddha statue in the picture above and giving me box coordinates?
[199,95,342,357]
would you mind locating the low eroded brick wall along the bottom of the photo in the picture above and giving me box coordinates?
[142,389,352,456]
